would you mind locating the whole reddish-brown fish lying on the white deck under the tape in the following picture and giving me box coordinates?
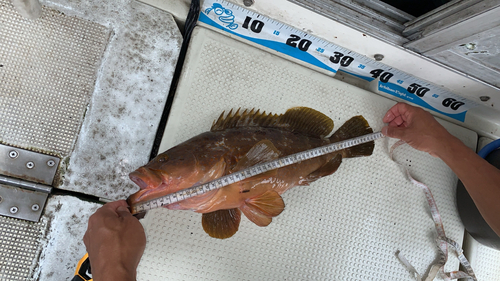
[127,107,375,239]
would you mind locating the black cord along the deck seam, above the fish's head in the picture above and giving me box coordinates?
[149,0,200,161]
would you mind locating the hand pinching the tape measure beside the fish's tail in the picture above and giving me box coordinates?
[382,103,456,157]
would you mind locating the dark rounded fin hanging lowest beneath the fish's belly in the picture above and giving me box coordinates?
[201,208,241,239]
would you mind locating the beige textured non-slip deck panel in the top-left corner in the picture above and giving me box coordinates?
[0,0,110,157]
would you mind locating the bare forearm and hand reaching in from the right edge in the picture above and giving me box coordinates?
[382,103,500,236]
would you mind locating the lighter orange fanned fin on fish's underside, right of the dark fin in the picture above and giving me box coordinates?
[240,190,285,226]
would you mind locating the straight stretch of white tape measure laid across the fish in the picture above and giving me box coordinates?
[130,132,384,214]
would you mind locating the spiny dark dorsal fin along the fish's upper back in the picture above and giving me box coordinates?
[210,107,333,137]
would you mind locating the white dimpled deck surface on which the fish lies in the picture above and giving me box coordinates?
[138,27,477,280]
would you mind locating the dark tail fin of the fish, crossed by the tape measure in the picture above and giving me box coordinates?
[330,115,375,158]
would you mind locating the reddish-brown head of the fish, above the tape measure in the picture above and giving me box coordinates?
[127,150,203,205]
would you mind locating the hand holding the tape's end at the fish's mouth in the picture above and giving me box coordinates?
[83,200,146,281]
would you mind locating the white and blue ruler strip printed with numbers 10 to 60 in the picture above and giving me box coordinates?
[199,0,477,122]
